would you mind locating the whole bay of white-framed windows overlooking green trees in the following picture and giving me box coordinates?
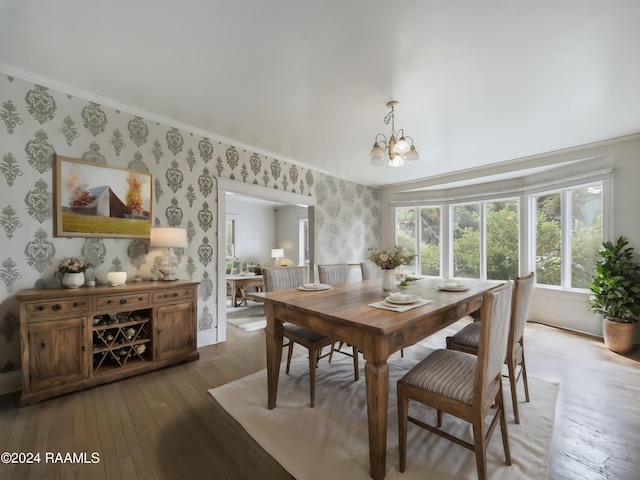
[395,175,611,289]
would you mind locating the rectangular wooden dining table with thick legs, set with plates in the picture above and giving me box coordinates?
[247,278,501,480]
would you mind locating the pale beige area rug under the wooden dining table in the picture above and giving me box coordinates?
[209,346,558,480]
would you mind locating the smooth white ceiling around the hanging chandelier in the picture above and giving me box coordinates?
[0,0,640,186]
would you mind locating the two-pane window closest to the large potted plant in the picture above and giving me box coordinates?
[535,182,604,288]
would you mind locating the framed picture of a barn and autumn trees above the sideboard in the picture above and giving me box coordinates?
[54,156,153,238]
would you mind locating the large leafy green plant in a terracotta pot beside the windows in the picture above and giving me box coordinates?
[589,236,640,353]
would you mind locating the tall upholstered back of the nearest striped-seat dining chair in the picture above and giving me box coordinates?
[476,280,513,403]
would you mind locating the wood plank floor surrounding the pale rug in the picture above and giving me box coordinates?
[0,323,640,480]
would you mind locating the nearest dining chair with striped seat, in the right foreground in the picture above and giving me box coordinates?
[398,281,513,480]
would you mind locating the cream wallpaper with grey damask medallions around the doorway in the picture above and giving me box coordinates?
[0,75,380,373]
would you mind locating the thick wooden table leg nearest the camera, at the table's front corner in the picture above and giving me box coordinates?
[364,360,389,480]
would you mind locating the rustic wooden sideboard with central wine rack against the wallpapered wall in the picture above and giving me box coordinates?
[16,280,199,406]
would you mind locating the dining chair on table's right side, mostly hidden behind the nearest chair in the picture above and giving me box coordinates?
[446,272,533,423]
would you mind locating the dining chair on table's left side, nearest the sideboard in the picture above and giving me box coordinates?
[262,267,356,407]
